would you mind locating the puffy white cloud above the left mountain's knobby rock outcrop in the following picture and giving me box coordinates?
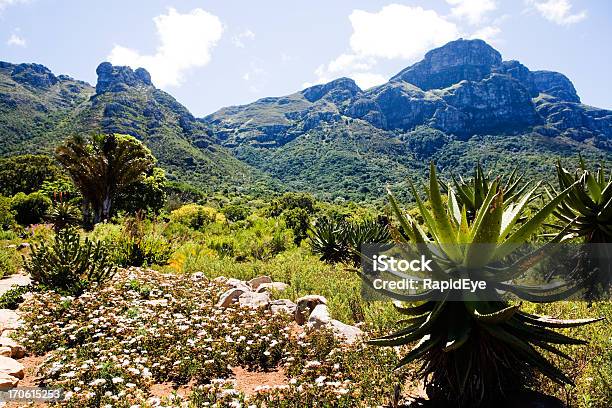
[108,8,223,88]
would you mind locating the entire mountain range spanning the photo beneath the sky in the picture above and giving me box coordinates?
[0,39,612,200]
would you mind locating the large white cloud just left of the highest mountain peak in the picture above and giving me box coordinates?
[304,4,460,89]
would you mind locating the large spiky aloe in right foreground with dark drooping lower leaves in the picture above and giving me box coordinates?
[362,163,599,406]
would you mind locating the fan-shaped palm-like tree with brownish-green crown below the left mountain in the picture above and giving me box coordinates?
[56,134,155,223]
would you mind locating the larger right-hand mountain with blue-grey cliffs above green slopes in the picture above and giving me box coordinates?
[202,40,612,199]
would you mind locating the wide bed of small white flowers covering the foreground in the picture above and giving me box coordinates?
[18,268,402,407]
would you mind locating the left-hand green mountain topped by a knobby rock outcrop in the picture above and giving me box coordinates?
[0,63,278,194]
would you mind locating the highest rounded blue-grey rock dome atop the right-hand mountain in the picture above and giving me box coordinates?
[391,39,502,90]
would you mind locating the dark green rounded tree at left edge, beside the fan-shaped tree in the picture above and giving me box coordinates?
[0,154,61,196]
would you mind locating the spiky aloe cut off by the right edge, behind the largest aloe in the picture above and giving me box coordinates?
[555,157,612,243]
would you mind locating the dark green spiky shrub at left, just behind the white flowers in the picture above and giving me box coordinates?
[23,228,116,295]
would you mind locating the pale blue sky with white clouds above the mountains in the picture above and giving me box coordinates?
[0,0,612,116]
